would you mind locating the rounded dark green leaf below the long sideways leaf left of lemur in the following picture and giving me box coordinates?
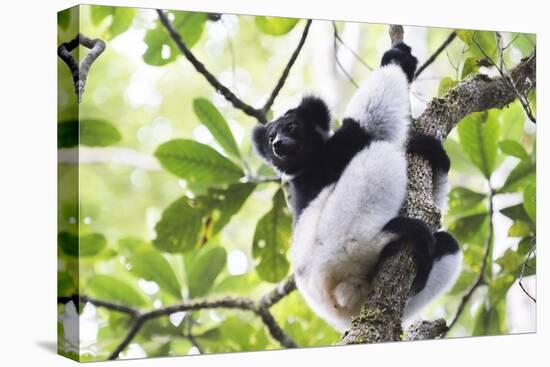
[153,196,203,253]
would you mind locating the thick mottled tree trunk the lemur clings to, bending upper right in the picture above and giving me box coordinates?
[341,26,536,344]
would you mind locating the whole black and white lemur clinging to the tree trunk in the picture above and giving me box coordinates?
[253,43,462,330]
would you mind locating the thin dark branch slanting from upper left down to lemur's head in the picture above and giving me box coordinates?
[157,9,267,123]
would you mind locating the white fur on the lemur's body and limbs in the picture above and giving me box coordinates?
[291,64,461,330]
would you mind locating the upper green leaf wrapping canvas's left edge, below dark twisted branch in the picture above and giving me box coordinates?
[57,119,122,148]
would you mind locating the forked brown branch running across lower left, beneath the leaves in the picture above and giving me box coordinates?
[57,275,297,360]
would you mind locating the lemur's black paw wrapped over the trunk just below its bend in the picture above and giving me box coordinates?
[407,133,451,175]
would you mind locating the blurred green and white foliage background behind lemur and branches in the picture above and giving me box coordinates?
[57,6,536,361]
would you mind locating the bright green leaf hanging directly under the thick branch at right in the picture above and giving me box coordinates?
[458,112,499,178]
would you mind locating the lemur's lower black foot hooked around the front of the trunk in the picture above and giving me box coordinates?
[379,217,436,294]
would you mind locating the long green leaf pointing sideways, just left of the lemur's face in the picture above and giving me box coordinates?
[155,139,244,184]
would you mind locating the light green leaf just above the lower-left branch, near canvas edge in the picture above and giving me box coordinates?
[86,275,148,307]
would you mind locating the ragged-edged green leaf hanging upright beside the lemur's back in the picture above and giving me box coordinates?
[252,189,292,282]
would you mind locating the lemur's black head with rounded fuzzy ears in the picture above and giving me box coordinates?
[252,97,330,174]
